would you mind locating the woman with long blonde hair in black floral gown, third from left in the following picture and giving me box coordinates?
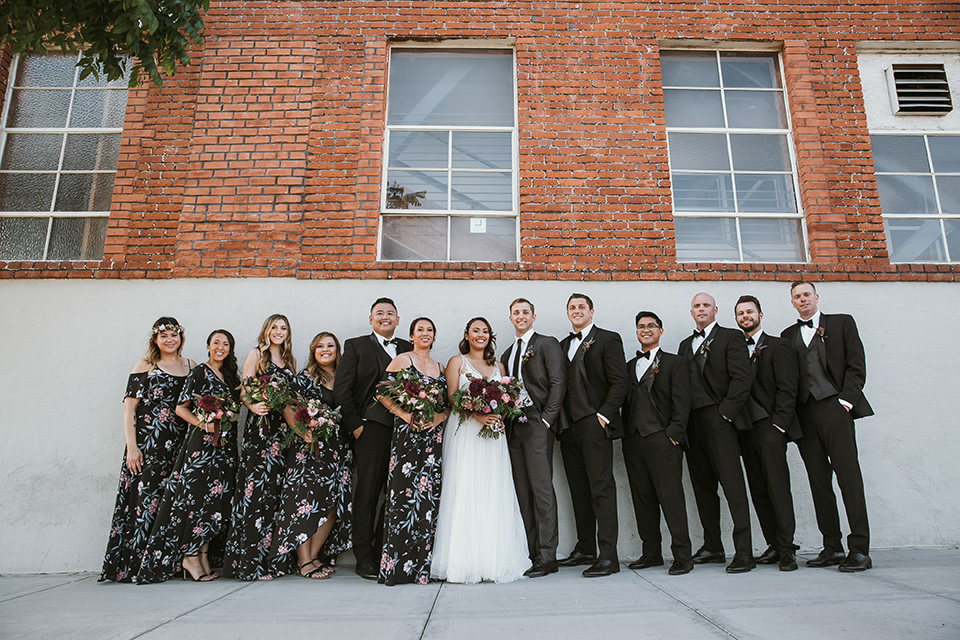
[223,313,297,580]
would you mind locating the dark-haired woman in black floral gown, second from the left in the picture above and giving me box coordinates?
[137,329,240,584]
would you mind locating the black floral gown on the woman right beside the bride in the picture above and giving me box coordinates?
[379,371,447,585]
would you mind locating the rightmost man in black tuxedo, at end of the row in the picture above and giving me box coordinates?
[780,281,873,572]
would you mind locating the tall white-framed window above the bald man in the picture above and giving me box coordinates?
[660,50,806,262]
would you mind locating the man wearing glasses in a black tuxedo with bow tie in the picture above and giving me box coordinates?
[622,311,693,576]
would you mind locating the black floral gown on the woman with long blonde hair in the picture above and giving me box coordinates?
[223,362,296,580]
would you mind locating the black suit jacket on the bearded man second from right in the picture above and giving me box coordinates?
[744,332,802,440]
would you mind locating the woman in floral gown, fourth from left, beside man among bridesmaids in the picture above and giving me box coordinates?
[275,332,350,579]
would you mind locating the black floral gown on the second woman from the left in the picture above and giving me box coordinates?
[137,364,239,584]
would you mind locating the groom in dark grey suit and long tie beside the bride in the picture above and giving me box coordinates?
[500,298,567,578]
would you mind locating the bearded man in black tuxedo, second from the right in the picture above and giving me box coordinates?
[733,296,801,571]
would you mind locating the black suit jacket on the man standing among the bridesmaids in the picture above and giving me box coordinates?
[333,333,413,433]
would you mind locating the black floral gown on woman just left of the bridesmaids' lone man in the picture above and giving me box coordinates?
[274,370,350,563]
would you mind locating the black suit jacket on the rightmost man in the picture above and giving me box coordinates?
[780,313,873,418]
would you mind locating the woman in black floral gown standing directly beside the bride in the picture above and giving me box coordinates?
[379,318,450,586]
